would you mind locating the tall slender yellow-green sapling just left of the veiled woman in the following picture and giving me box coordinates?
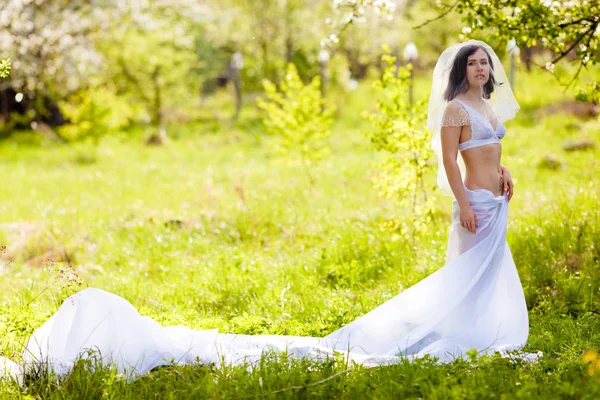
[363,46,435,240]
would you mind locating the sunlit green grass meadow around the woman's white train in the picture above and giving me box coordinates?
[0,69,600,399]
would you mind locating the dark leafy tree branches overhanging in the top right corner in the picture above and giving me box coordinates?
[421,0,600,104]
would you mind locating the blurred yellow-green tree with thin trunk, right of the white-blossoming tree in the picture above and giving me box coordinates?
[98,0,209,135]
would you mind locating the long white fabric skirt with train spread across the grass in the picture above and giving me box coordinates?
[0,187,541,376]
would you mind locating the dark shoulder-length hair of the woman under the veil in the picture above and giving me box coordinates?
[444,44,498,101]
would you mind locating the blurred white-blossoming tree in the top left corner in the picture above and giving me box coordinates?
[0,0,105,125]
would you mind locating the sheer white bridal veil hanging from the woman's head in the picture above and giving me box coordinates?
[427,40,520,196]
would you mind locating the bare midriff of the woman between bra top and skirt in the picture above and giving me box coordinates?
[461,126,503,196]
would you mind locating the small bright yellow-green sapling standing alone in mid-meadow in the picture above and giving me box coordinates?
[257,64,333,182]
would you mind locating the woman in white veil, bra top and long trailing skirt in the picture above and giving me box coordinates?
[0,41,539,382]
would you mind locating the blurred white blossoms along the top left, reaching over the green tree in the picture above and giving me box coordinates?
[0,0,207,95]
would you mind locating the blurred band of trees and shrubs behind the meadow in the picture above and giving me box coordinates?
[0,0,597,141]
